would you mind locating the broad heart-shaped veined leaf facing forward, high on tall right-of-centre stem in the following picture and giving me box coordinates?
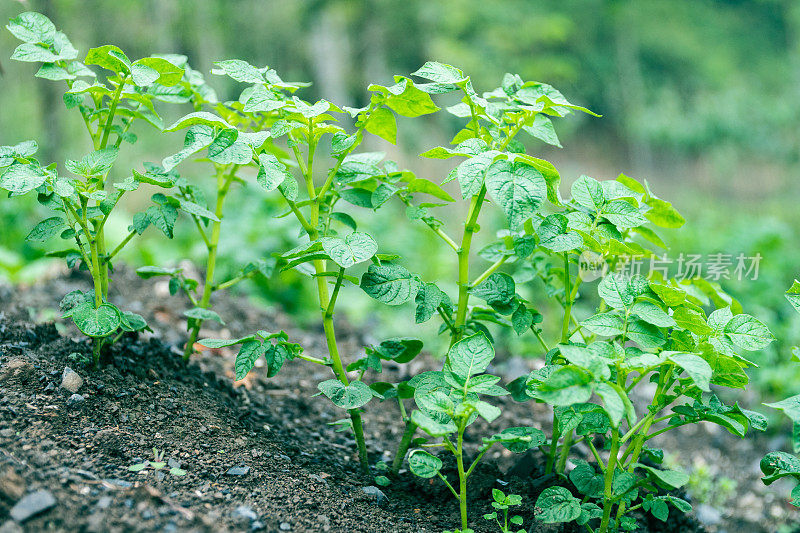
[486,159,547,229]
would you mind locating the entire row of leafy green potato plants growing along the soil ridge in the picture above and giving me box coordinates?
[0,12,800,533]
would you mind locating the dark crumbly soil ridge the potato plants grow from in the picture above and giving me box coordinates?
[0,271,796,533]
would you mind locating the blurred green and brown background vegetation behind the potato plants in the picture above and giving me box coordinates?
[0,0,800,406]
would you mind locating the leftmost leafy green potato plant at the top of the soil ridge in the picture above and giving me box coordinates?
[0,12,216,364]
